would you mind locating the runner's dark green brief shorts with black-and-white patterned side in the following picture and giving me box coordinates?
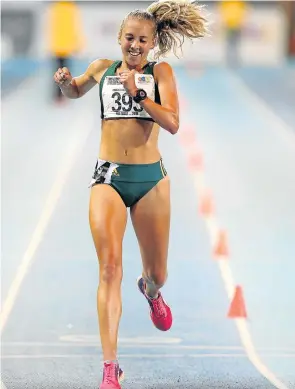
[89,159,167,207]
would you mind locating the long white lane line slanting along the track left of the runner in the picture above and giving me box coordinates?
[0,111,94,333]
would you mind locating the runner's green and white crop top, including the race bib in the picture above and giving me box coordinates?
[99,61,161,121]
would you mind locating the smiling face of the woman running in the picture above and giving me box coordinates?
[119,18,155,68]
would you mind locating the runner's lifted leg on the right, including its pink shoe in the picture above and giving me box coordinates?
[131,176,172,331]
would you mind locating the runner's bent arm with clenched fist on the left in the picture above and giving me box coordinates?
[53,59,111,99]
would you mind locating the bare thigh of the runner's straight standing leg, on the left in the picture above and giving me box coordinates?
[89,184,127,265]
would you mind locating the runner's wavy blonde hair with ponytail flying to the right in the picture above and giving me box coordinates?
[118,0,208,59]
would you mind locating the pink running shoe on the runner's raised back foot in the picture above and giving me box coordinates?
[137,276,172,331]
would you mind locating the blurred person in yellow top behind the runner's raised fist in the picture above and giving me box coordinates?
[48,0,83,101]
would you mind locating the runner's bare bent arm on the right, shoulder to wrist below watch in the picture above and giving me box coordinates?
[140,62,179,135]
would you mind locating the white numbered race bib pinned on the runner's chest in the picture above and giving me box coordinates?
[102,73,155,119]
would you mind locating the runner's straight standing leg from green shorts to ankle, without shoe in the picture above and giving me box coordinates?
[89,184,127,361]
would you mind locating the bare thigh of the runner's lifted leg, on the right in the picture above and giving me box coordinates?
[131,176,170,271]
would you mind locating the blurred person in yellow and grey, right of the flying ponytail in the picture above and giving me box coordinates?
[219,1,246,67]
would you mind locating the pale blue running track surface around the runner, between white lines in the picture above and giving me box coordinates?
[1,64,295,389]
